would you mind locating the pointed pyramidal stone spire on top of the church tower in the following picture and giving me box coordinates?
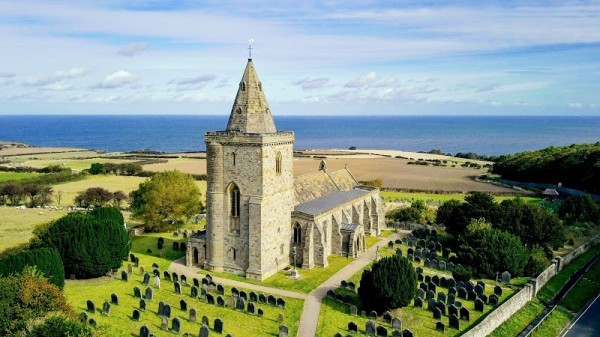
[227,58,276,133]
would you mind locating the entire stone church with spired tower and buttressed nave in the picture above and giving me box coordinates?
[186,58,384,280]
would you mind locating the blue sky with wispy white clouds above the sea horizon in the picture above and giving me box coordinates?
[0,0,600,115]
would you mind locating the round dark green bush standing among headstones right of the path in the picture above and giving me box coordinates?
[358,256,417,312]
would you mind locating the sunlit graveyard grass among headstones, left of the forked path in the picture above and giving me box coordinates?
[64,266,304,336]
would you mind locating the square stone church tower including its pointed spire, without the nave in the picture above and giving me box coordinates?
[204,58,294,280]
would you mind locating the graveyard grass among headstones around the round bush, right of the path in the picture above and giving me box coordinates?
[317,243,514,337]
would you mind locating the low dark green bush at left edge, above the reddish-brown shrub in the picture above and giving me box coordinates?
[0,248,65,289]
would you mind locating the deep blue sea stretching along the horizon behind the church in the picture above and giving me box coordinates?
[0,115,600,155]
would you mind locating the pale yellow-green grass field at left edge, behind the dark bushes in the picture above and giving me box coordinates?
[0,206,67,252]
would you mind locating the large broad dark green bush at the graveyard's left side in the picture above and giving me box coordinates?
[32,207,129,278]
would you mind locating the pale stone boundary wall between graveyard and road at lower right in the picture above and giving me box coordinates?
[462,235,600,337]
